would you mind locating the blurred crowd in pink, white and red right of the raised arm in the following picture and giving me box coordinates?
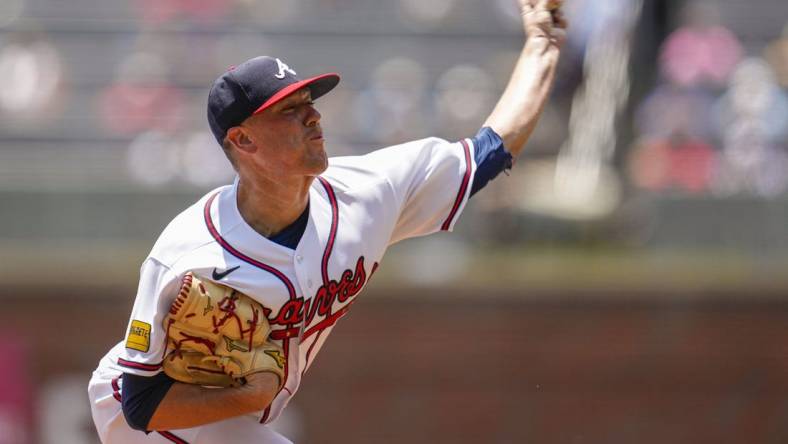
[628,2,788,198]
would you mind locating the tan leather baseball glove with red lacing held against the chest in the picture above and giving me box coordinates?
[162,272,285,387]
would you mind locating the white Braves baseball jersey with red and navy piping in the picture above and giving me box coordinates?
[91,138,476,442]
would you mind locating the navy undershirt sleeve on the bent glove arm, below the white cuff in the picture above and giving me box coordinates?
[121,372,175,431]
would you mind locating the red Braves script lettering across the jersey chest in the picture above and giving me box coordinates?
[269,256,367,325]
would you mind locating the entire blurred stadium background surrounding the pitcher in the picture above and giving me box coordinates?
[0,0,788,444]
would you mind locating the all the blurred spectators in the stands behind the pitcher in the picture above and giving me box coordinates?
[0,0,788,197]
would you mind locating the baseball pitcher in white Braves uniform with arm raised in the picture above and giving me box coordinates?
[88,0,566,444]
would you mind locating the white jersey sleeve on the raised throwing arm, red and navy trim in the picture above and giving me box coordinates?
[326,138,476,244]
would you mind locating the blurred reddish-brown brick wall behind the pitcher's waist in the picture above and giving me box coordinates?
[6,292,788,444]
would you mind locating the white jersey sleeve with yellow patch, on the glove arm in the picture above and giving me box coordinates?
[117,257,180,376]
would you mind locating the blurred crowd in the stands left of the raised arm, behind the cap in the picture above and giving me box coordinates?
[0,0,556,188]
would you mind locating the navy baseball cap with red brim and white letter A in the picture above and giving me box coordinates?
[208,56,339,145]
